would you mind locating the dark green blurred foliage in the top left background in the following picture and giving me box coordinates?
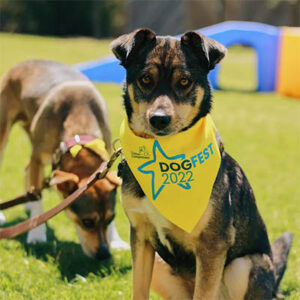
[0,0,124,37]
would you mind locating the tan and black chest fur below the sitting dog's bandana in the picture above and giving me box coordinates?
[121,162,211,274]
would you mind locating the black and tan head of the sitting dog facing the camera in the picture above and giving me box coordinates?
[111,28,226,137]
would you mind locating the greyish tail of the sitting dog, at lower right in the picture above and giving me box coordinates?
[271,232,294,295]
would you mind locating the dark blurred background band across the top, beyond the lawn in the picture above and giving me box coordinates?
[0,0,300,38]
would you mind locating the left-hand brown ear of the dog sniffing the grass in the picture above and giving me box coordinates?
[49,170,79,193]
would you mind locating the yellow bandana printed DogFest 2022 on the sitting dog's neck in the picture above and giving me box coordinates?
[120,115,221,232]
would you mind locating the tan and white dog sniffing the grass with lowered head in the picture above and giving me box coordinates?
[0,60,129,259]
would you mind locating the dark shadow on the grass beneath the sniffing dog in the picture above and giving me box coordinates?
[3,218,131,281]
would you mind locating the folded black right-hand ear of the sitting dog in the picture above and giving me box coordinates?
[181,31,227,71]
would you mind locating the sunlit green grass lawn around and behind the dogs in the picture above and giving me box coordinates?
[0,34,300,300]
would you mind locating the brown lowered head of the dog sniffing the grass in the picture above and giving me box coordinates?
[50,148,121,259]
